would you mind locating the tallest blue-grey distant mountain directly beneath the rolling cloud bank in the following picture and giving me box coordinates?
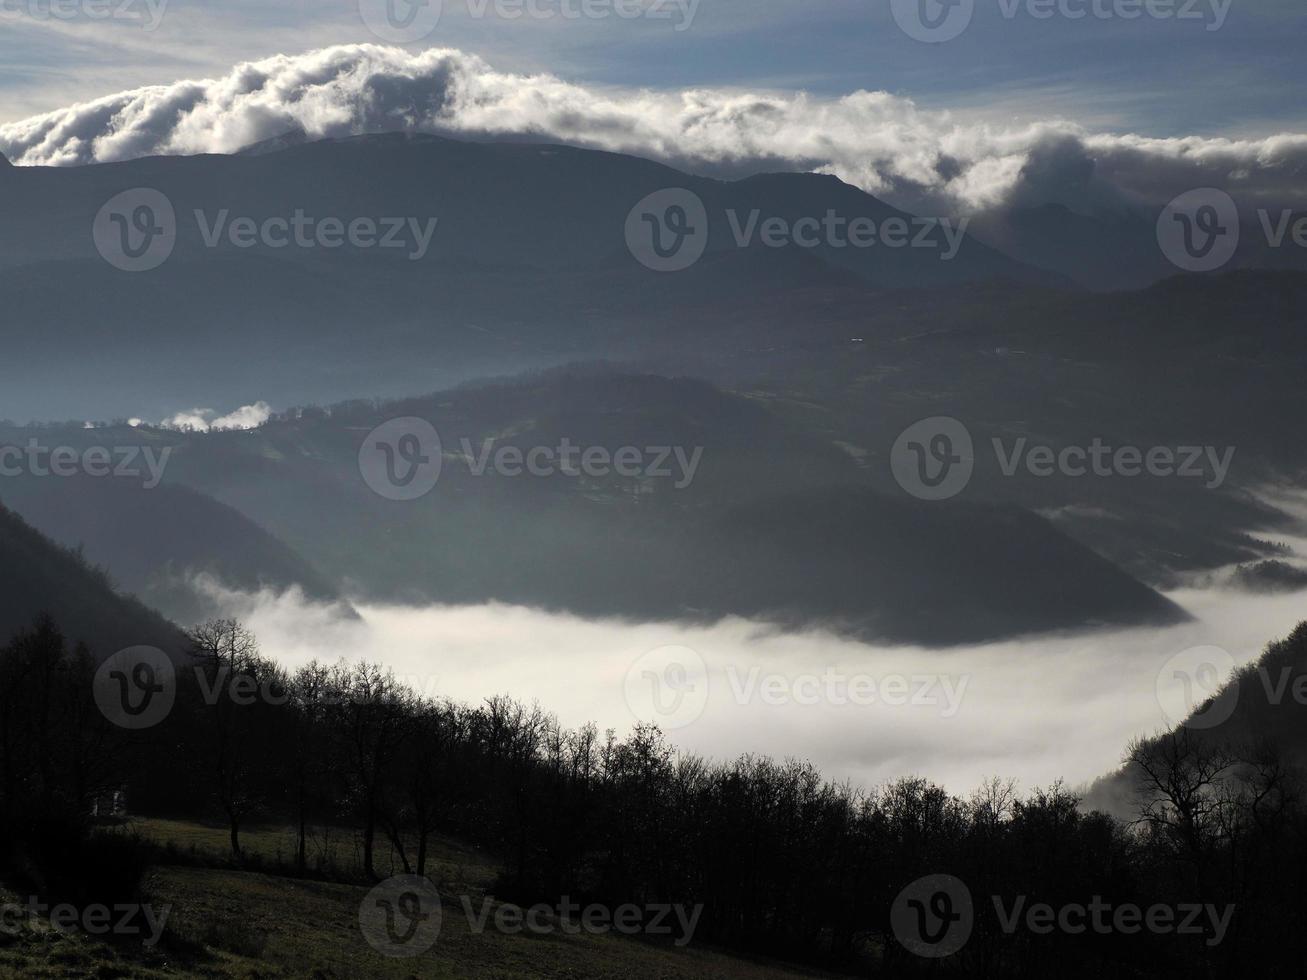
[0,135,1060,418]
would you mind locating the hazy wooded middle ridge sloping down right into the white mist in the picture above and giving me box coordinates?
[117,370,1183,643]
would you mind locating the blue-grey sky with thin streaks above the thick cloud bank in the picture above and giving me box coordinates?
[0,0,1307,137]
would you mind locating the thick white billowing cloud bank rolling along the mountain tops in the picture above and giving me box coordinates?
[0,44,1307,210]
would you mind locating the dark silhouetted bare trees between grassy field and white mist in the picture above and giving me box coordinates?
[0,621,1307,977]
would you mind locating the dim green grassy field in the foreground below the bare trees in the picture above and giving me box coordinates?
[0,821,825,980]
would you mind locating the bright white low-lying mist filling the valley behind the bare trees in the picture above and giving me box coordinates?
[193,581,1307,793]
